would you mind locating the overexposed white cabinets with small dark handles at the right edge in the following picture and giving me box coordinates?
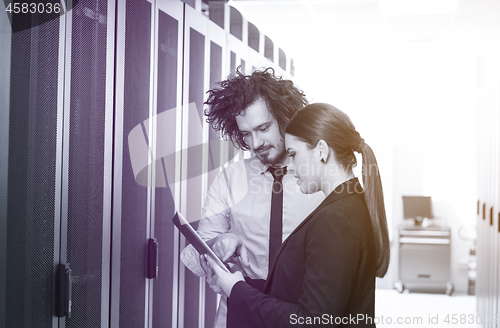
[476,73,500,327]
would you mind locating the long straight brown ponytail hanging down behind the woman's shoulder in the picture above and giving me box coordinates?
[357,144,390,278]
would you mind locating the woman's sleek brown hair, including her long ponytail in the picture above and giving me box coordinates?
[286,103,390,277]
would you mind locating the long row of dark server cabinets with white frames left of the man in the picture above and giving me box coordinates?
[0,0,289,327]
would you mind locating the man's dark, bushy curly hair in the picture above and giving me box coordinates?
[205,67,307,150]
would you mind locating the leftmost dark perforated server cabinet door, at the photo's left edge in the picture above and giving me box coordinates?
[0,9,64,327]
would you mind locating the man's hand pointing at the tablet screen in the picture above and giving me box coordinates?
[212,233,249,267]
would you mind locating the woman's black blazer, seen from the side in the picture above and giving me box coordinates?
[227,178,375,328]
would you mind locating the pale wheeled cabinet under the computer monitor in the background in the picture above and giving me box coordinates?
[394,219,453,295]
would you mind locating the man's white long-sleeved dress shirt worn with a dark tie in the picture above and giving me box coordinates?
[181,157,324,328]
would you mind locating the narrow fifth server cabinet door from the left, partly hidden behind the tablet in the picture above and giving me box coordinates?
[178,4,209,328]
